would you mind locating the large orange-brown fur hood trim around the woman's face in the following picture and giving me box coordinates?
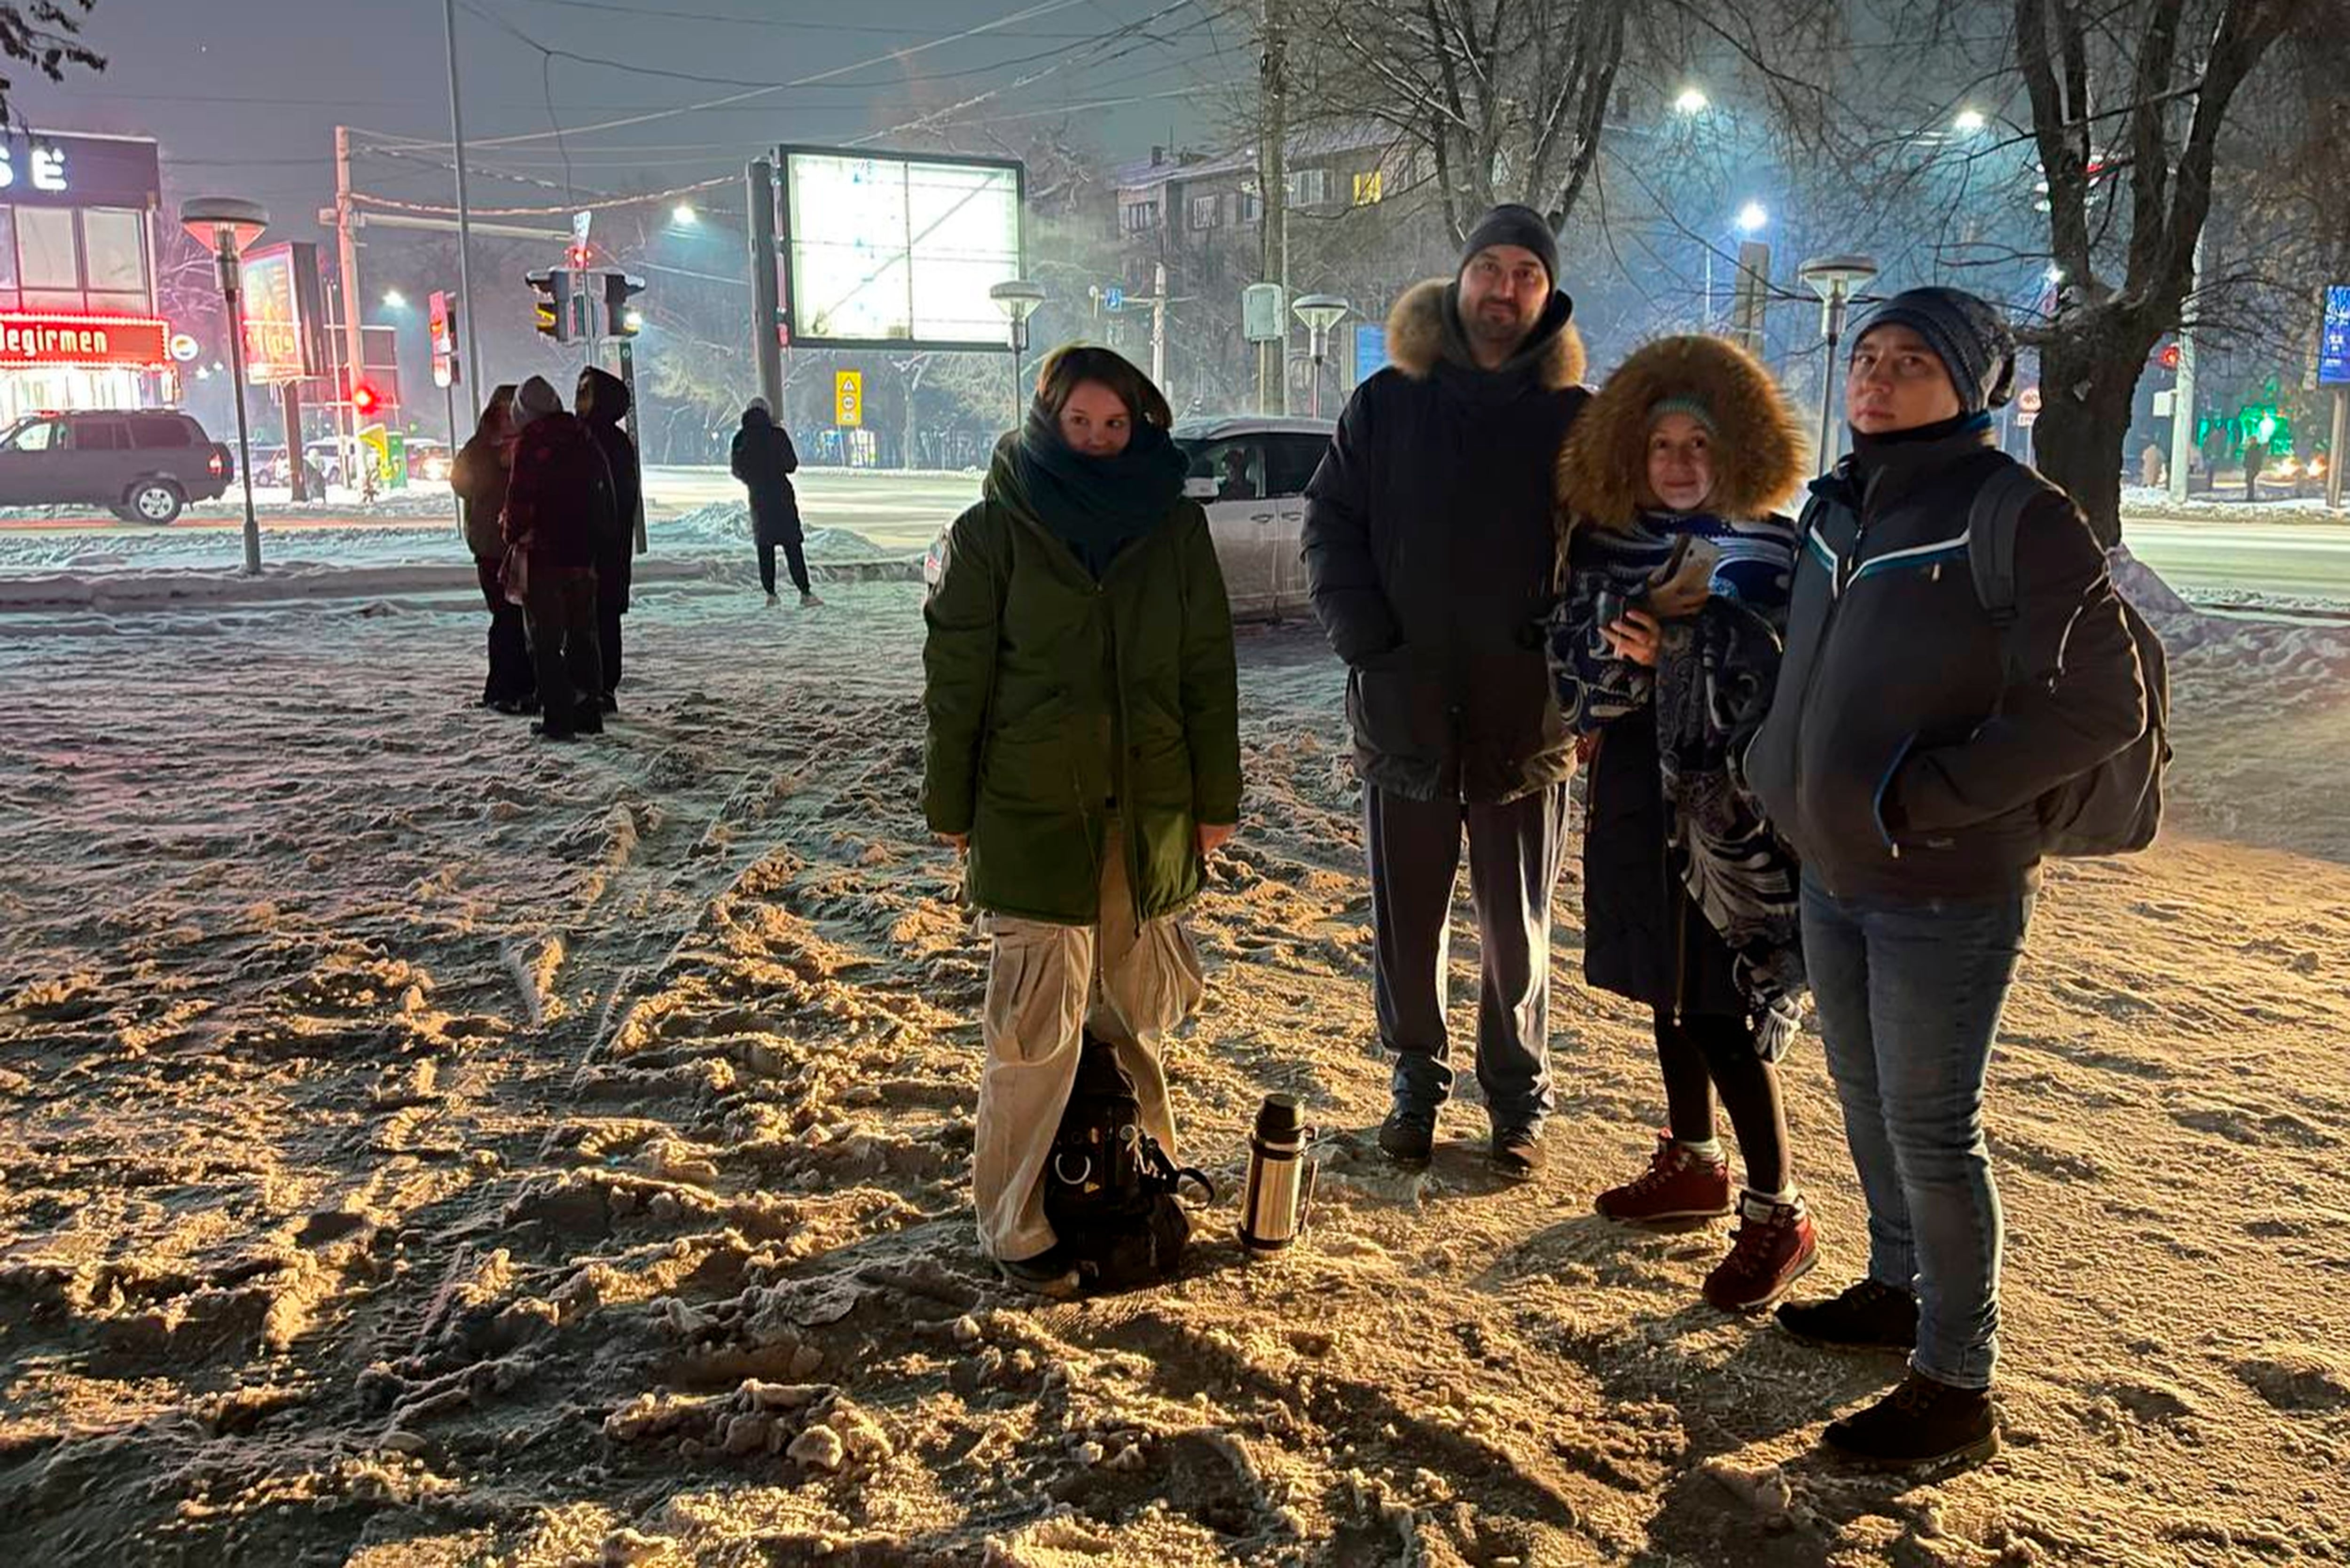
[1558,334,1810,529]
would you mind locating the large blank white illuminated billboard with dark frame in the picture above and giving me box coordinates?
[776,148,1025,350]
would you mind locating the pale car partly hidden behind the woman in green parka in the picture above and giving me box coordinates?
[921,414,1337,621]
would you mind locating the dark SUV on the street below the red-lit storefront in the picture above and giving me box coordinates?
[0,409,237,522]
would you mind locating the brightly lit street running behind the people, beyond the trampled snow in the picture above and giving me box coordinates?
[14,466,2350,604]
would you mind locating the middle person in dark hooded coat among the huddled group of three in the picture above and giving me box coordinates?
[505,376,618,741]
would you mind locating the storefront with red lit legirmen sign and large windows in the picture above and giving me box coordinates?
[0,132,176,426]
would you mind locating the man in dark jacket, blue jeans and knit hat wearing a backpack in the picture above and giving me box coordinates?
[1746,289,2167,1467]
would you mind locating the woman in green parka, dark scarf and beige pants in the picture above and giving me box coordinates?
[921,345,1241,1295]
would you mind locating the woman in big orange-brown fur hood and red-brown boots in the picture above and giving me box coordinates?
[1551,336,1817,1312]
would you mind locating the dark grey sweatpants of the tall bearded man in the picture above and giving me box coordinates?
[1363,783,1567,1131]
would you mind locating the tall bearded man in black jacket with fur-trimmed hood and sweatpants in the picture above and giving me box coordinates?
[1304,207,1586,1178]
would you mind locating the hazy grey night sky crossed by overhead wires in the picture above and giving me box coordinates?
[12,0,1255,237]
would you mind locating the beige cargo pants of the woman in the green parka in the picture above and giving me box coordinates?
[971,818,1208,1260]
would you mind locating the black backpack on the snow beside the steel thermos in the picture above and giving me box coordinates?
[1043,1030,1215,1291]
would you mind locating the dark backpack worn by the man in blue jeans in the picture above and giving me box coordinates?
[1967,463,2171,856]
